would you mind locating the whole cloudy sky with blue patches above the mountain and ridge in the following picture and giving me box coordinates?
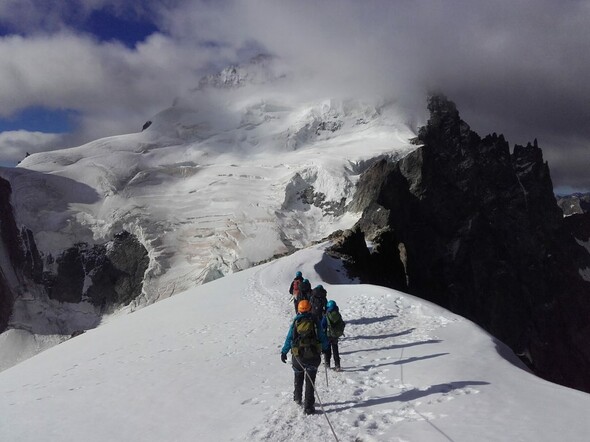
[0,0,590,190]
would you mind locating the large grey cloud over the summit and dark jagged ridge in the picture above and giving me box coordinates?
[161,0,590,190]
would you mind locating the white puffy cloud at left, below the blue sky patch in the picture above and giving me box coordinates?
[0,32,220,152]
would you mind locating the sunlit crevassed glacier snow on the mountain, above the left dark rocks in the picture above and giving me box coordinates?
[0,84,415,304]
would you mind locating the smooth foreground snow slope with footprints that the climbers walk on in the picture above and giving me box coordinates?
[0,246,590,442]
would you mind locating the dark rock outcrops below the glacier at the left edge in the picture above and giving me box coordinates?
[0,174,149,332]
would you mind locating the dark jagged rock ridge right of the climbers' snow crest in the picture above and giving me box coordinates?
[334,96,590,391]
